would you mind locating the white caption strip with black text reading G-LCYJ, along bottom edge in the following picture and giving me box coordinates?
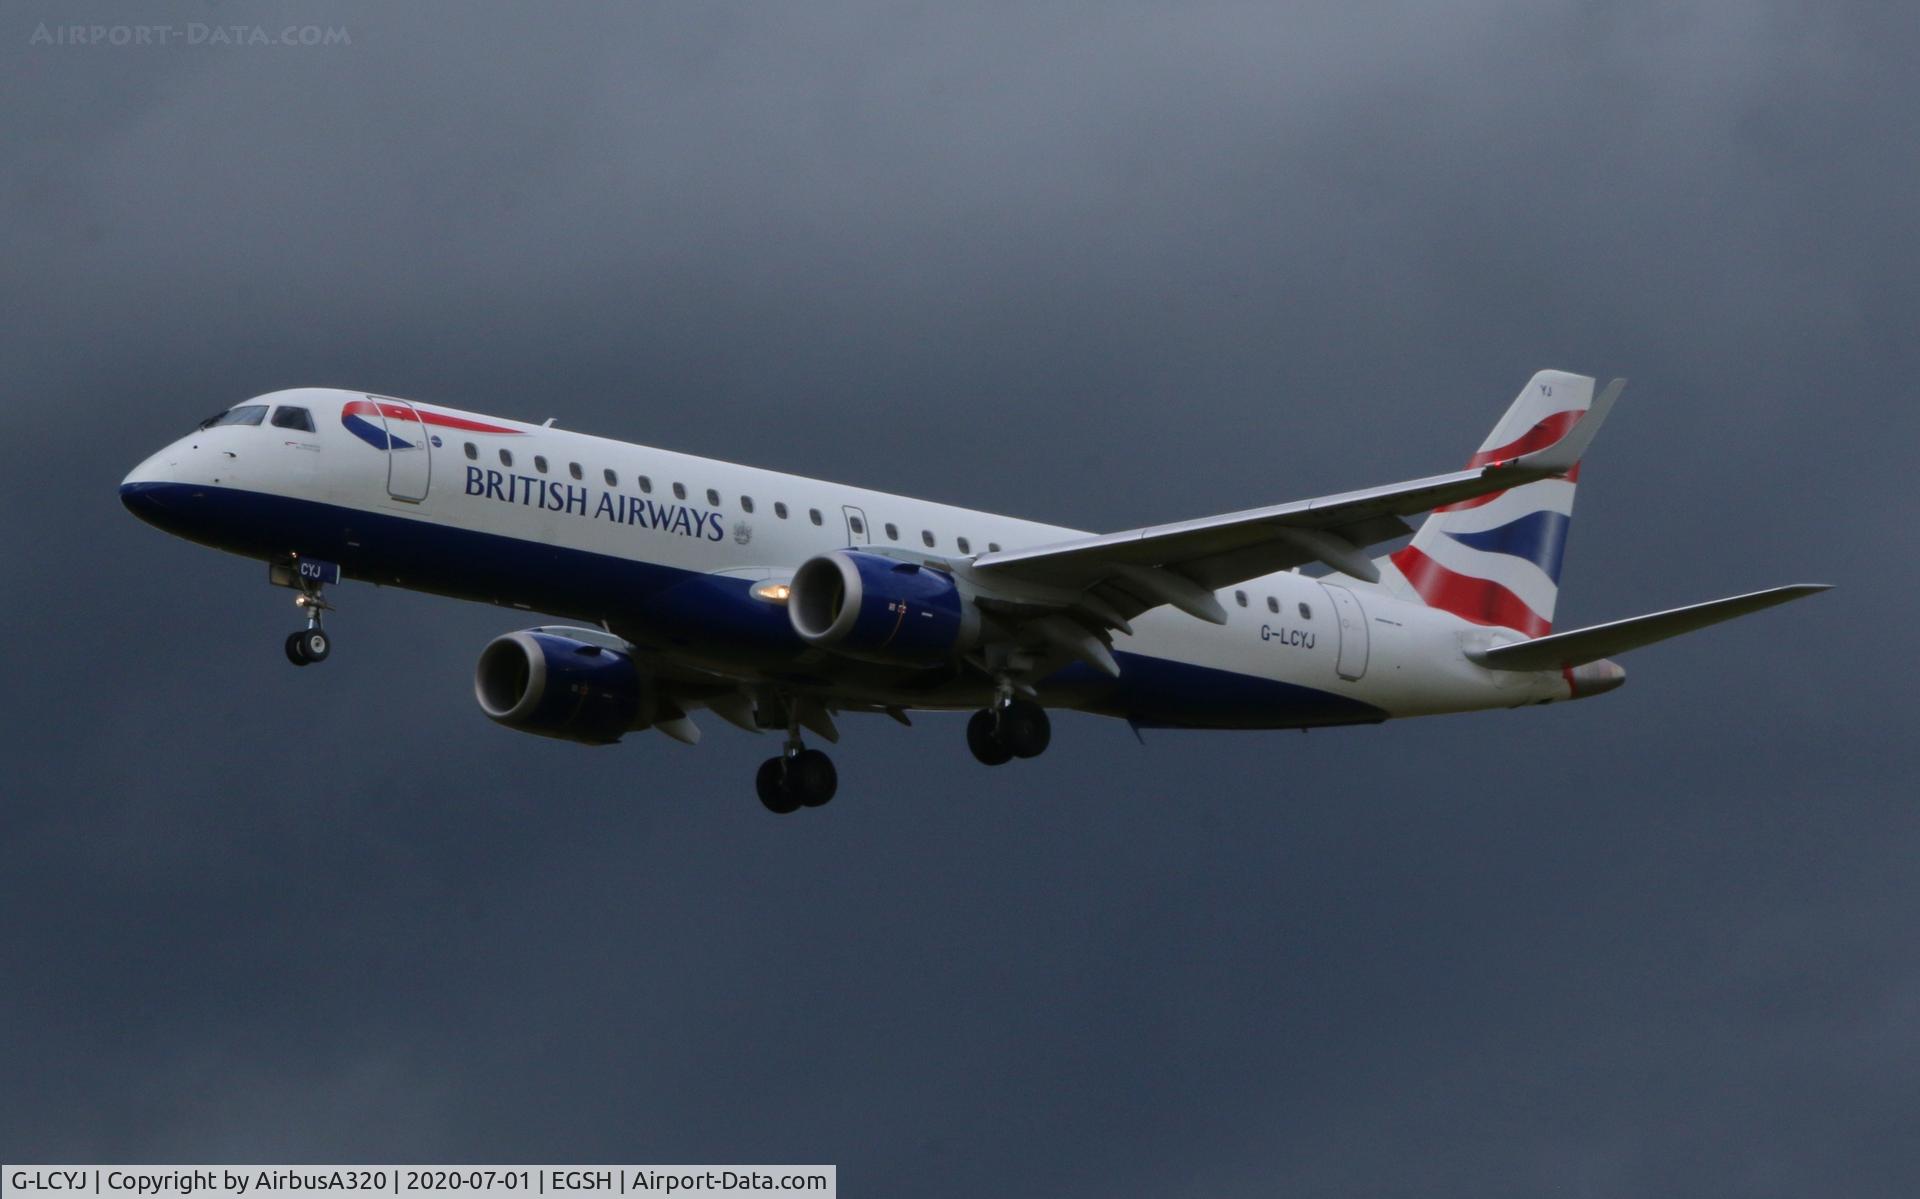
[0,1164,839,1199]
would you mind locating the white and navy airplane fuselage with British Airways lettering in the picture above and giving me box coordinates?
[123,388,1572,728]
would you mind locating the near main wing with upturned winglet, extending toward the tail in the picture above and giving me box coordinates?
[972,379,1626,628]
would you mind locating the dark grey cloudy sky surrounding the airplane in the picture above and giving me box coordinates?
[0,2,1920,1197]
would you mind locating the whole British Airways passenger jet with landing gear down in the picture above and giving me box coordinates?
[119,371,1828,815]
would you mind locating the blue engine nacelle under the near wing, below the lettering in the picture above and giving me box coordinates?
[787,550,979,665]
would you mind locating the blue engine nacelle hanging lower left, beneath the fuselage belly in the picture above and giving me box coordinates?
[474,628,655,746]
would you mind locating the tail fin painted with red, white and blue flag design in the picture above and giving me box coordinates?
[1377,371,1594,638]
